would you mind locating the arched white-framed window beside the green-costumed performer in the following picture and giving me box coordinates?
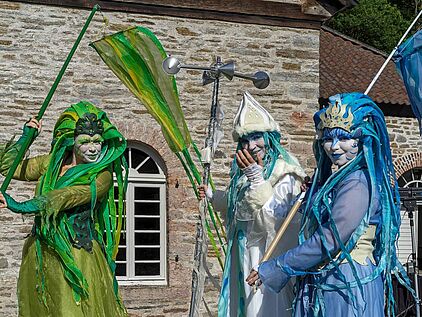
[116,142,167,285]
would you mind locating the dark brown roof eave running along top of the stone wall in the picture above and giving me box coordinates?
[20,0,338,30]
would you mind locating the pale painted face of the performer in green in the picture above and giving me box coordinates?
[73,134,104,164]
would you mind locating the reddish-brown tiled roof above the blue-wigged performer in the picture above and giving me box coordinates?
[319,26,410,106]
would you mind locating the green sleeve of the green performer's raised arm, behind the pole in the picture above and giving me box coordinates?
[0,126,50,181]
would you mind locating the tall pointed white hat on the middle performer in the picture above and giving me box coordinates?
[232,91,280,141]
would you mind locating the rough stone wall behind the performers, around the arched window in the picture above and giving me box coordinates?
[0,1,319,316]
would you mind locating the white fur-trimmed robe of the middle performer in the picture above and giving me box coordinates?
[214,159,305,317]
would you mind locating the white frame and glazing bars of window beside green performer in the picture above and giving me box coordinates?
[116,142,168,285]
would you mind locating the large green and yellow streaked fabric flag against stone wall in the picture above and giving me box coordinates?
[91,27,191,152]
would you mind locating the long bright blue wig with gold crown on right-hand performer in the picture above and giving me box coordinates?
[300,93,413,315]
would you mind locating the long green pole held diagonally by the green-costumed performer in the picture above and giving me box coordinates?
[0,4,100,192]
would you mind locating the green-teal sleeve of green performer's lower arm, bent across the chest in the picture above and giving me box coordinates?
[3,170,112,215]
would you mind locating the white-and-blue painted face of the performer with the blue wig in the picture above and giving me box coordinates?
[322,129,359,167]
